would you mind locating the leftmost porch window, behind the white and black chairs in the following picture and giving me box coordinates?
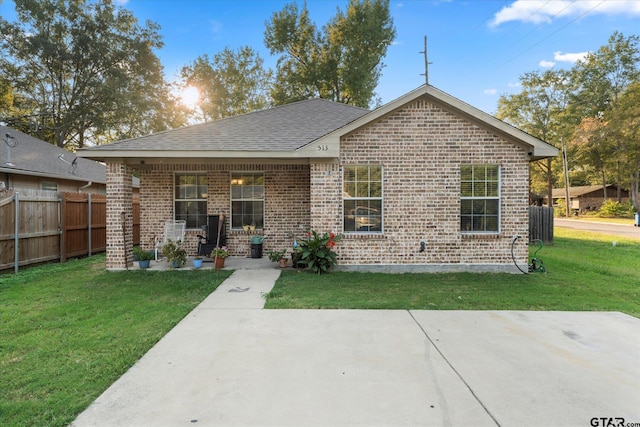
[174,173,207,228]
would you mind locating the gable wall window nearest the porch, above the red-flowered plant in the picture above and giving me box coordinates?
[342,165,382,233]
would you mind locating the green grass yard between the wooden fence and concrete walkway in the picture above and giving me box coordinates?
[0,255,230,426]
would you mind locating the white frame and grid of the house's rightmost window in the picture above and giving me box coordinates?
[460,163,502,235]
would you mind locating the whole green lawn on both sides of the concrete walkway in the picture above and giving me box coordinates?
[0,229,640,426]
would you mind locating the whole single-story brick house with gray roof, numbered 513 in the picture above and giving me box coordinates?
[78,86,558,271]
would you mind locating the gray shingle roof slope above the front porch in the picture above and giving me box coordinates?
[85,99,369,151]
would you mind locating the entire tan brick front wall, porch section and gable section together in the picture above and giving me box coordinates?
[134,95,529,267]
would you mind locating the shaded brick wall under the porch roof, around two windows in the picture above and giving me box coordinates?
[140,164,309,256]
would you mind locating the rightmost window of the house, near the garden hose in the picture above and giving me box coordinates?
[460,165,500,233]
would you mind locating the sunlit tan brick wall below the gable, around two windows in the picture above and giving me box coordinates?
[311,99,528,266]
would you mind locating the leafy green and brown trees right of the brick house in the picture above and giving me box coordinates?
[497,32,640,212]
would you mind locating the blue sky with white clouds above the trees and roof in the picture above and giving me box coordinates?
[0,0,640,114]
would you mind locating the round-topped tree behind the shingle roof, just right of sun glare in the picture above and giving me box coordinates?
[182,46,272,120]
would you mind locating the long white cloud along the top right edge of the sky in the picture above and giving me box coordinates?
[489,0,640,27]
